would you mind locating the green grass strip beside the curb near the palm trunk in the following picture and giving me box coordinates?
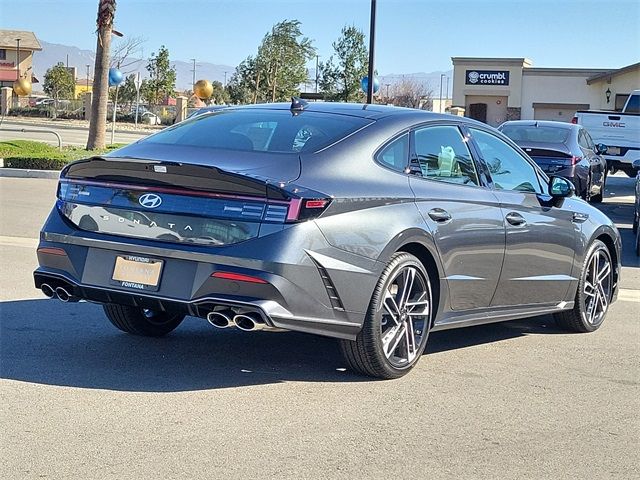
[0,140,124,170]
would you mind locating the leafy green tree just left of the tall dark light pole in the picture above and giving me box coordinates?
[319,26,369,102]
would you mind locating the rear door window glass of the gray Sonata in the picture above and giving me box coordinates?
[412,126,480,185]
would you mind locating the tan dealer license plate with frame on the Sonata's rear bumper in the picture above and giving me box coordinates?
[110,254,164,292]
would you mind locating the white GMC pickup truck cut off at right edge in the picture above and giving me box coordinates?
[572,90,640,177]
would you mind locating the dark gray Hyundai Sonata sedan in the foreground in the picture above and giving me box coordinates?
[34,100,621,378]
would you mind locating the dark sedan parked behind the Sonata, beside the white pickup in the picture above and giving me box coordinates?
[498,120,607,203]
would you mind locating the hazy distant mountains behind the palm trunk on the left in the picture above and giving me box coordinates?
[33,40,235,90]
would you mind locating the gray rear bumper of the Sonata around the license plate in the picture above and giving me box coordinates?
[34,208,382,339]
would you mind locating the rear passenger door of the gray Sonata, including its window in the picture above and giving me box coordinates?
[409,124,505,311]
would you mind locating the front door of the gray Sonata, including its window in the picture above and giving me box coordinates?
[469,128,580,307]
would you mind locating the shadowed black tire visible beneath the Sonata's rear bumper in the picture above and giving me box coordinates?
[103,303,184,337]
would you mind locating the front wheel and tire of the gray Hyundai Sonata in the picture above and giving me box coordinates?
[554,240,614,333]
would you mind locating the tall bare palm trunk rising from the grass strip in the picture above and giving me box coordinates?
[87,0,116,150]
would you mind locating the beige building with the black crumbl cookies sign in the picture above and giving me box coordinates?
[451,57,640,126]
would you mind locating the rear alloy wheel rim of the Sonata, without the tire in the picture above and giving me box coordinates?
[378,266,431,368]
